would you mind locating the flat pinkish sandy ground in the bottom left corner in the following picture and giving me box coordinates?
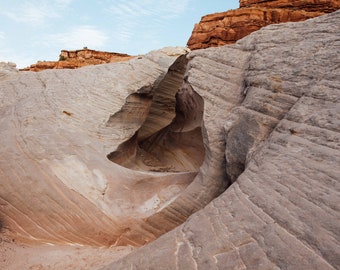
[0,235,134,270]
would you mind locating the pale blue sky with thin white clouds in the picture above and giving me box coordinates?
[0,0,239,68]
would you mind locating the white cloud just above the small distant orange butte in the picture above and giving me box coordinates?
[44,25,109,49]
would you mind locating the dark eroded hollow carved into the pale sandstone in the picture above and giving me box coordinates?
[107,56,204,172]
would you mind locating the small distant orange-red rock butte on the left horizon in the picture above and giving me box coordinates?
[21,48,133,71]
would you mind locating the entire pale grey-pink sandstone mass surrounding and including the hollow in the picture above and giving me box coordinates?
[0,12,340,269]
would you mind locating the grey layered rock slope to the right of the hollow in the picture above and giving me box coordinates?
[103,12,340,270]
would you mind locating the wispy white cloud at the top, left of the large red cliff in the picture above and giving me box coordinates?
[109,0,190,42]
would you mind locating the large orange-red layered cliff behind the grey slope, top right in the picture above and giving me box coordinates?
[187,0,340,50]
